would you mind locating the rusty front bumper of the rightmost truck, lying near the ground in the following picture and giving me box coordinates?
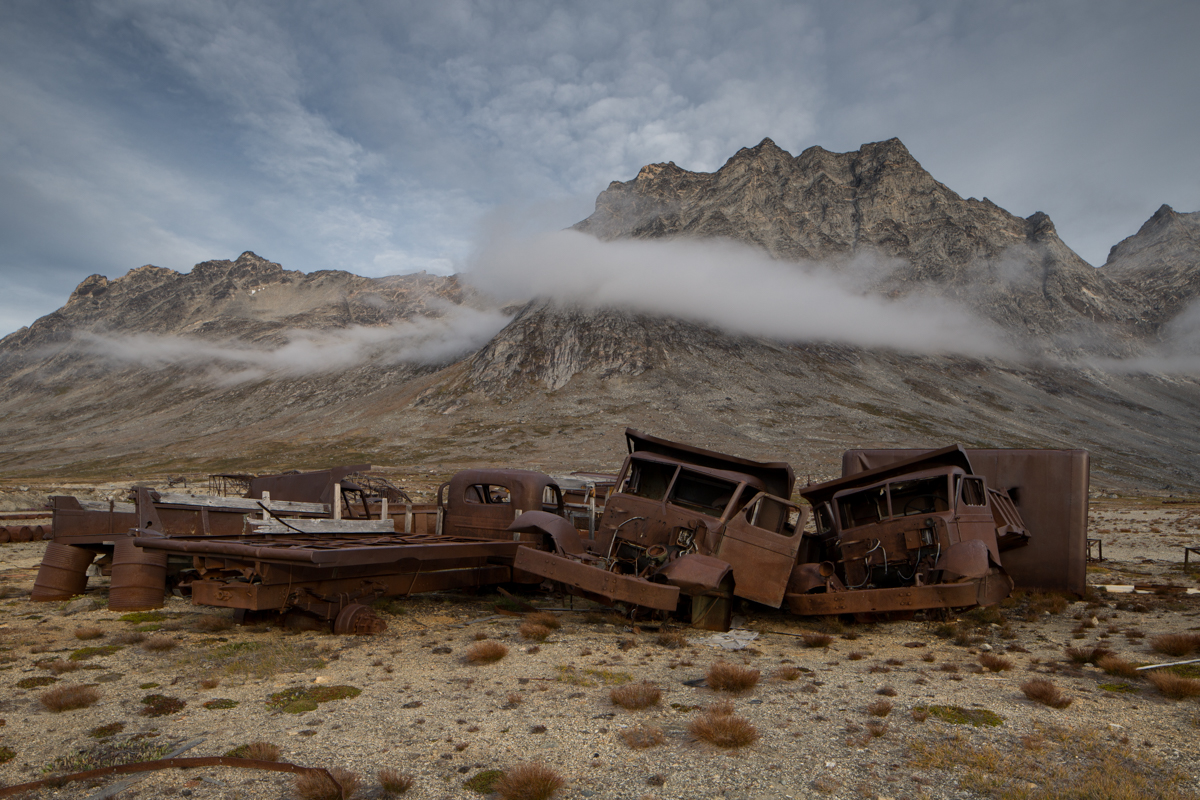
[787,573,1013,615]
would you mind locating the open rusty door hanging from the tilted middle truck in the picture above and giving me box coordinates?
[716,492,809,608]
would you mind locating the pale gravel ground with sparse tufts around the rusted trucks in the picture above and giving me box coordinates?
[0,499,1200,799]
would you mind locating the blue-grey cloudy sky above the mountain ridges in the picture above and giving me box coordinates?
[0,0,1200,335]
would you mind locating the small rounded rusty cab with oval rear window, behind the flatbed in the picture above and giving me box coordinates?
[438,469,564,546]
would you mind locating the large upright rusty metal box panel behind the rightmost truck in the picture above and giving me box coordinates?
[842,450,1091,595]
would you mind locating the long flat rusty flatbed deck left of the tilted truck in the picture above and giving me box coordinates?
[133,531,521,566]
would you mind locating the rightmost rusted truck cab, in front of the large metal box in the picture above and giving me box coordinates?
[787,445,1028,614]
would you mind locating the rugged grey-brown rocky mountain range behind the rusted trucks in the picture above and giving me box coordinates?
[0,139,1200,489]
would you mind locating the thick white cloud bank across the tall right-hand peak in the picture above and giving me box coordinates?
[469,230,1013,356]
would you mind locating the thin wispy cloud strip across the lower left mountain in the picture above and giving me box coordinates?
[76,306,510,383]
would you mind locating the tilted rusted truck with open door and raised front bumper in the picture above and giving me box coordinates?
[510,429,808,630]
